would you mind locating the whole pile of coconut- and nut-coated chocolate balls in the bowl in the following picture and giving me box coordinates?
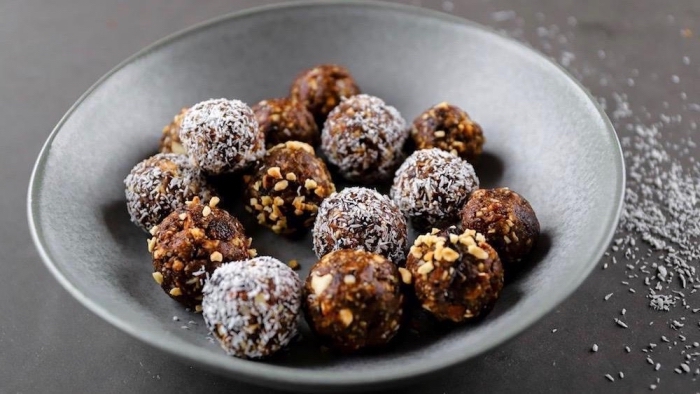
[124,64,540,359]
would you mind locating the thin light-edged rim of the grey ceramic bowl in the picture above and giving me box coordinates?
[27,0,626,387]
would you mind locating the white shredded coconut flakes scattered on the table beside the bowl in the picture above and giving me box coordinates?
[484,11,700,390]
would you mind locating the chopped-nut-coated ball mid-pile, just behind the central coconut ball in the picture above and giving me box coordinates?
[246,141,335,234]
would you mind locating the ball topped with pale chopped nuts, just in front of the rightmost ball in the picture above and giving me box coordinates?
[401,226,503,323]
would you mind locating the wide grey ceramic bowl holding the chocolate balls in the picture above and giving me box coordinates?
[28,2,624,391]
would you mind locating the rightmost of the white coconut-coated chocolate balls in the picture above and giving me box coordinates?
[391,148,479,229]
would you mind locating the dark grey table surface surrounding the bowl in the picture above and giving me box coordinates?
[0,0,700,393]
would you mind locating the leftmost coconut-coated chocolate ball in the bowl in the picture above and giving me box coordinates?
[124,153,211,231]
